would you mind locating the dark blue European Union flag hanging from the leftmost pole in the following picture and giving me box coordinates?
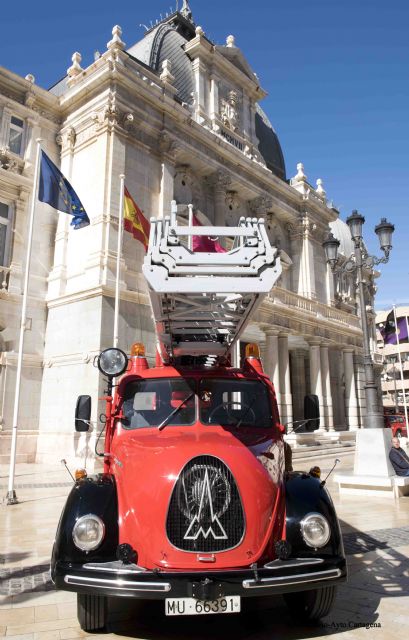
[38,151,89,229]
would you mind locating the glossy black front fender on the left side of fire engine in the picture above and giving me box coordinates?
[51,474,119,579]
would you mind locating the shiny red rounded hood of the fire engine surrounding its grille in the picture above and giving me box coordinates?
[111,427,284,571]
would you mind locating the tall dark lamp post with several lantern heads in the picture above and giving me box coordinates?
[322,210,395,429]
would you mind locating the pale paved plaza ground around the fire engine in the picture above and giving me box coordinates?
[0,456,409,640]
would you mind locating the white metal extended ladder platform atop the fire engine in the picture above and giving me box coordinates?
[142,201,281,362]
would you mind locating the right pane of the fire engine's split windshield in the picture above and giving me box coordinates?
[199,378,273,429]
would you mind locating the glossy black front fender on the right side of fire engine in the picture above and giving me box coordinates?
[285,472,345,558]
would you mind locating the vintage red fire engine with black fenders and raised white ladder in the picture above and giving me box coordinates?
[51,203,346,631]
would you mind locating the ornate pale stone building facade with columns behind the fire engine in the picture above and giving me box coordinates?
[0,2,382,460]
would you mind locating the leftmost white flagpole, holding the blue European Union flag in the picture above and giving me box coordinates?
[6,138,42,505]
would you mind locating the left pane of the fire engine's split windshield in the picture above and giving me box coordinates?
[122,378,195,429]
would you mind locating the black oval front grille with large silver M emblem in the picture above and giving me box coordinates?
[166,456,245,553]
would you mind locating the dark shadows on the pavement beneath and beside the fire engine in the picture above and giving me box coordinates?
[0,521,409,640]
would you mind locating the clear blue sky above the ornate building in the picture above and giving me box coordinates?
[0,0,409,308]
